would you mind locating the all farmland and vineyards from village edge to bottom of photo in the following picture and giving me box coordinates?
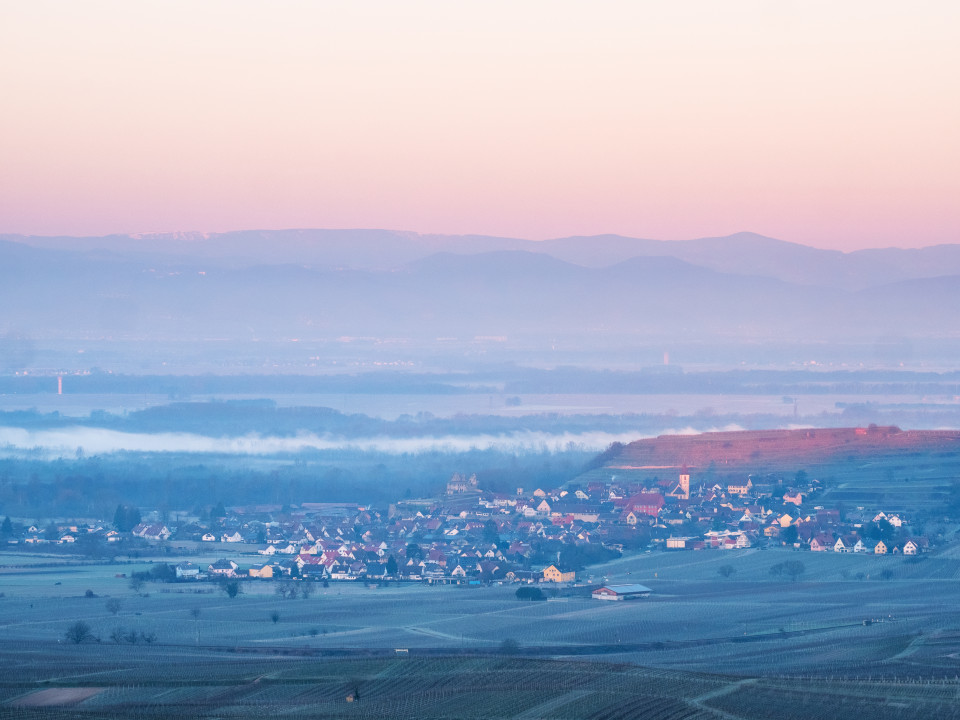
[0,550,960,719]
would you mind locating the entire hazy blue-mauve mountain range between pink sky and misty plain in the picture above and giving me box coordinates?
[0,230,960,344]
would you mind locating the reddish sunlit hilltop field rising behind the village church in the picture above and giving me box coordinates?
[607,426,960,470]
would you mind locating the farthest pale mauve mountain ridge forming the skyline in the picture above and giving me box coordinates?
[7,229,960,290]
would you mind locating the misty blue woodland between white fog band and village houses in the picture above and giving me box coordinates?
[0,449,594,516]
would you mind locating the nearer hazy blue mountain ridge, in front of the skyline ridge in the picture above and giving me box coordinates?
[0,238,960,341]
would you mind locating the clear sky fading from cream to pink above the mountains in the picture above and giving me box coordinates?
[0,0,960,251]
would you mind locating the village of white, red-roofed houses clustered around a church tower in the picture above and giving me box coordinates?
[0,469,930,584]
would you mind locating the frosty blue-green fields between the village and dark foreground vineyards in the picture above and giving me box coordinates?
[0,550,960,673]
